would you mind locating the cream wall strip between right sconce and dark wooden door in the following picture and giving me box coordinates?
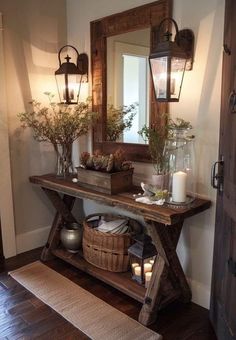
[170,0,224,307]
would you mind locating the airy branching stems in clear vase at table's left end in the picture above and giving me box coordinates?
[18,92,97,176]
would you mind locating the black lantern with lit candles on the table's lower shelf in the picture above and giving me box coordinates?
[128,234,157,288]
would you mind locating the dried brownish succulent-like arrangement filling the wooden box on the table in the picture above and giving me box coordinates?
[80,149,132,172]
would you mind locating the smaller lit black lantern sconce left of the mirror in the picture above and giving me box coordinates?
[55,45,88,104]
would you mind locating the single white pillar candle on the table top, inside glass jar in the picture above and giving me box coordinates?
[172,171,187,203]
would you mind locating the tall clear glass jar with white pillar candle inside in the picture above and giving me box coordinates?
[166,128,196,205]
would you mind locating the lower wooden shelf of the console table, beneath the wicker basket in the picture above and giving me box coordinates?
[51,248,146,303]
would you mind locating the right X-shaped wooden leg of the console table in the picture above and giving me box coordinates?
[139,221,192,325]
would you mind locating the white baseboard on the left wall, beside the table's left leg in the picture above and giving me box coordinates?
[16,226,51,254]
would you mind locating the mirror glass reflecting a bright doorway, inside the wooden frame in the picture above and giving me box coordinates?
[107,28,150,144]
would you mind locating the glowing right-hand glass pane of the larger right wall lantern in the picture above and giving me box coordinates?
[170,57,186,100]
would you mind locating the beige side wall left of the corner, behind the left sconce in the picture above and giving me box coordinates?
[0,0,67,257]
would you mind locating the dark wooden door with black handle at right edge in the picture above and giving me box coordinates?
[210,0,236,340]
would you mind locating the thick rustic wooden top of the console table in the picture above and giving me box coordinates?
[29,174,211,225]
